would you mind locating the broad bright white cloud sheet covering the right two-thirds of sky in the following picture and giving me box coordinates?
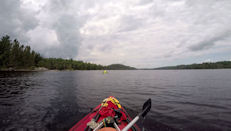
[79,0,231,67]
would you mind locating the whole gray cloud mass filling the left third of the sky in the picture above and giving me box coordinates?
[0,0,84,58]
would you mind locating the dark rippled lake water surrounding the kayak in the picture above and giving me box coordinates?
[0,70,231,131]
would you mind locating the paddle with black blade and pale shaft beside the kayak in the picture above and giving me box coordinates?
[122,98,152,131]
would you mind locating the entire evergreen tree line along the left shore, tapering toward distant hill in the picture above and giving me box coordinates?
[0,35,106,70]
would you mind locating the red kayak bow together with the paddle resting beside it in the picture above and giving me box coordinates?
[69,96,151,131]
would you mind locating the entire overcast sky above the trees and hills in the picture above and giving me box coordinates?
[0,0,231,68]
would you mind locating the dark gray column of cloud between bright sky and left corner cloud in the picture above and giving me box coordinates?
[28,0,85,58]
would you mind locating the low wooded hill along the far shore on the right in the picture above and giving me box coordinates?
[154,61,231,70]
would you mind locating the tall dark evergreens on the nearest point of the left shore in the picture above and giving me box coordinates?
[0,35,42,68]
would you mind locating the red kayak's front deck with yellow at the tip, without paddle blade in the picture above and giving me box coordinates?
[69,96,140,131]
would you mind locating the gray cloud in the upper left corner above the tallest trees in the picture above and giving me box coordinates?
[0,0,38,42]
